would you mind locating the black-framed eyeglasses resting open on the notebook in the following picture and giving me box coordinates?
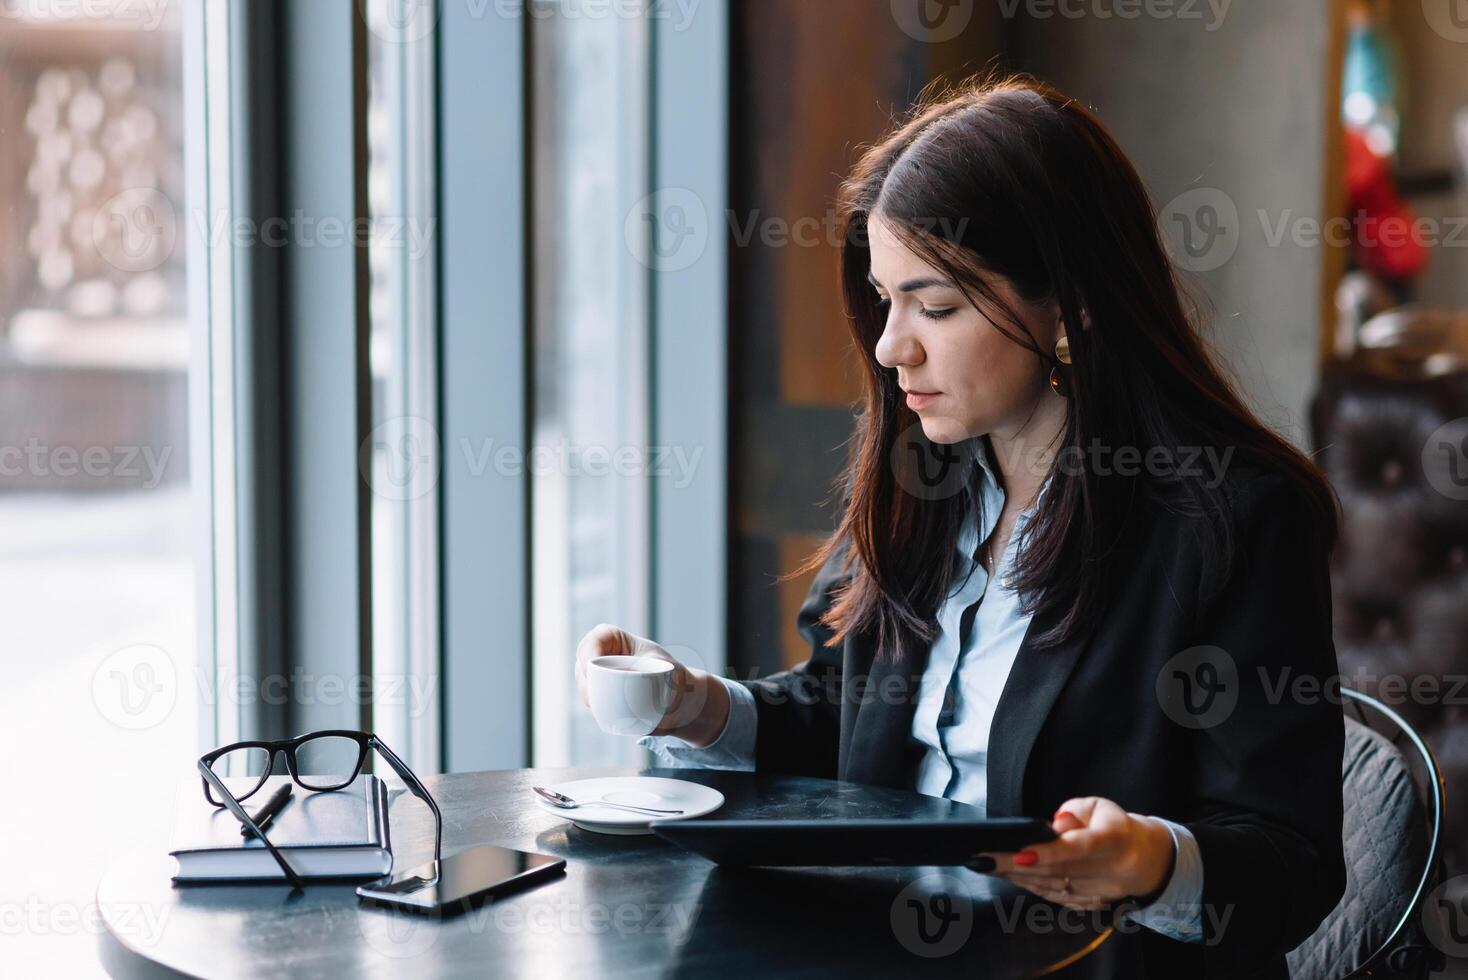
[198,729,443,888]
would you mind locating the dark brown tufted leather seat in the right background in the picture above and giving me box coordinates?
[1311,359,1468,874]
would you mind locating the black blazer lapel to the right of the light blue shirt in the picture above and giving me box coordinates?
[988,601,1095,817]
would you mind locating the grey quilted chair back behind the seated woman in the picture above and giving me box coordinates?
[1287,717,1428,980]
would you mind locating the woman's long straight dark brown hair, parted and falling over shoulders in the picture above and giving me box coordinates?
[791,75,1339,657]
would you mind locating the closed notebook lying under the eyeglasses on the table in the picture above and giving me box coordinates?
[169,775,392,882]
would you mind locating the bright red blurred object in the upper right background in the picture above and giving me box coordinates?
[1345,129,1427,280]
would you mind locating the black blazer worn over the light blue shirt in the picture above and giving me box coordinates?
[744,468,1345,979]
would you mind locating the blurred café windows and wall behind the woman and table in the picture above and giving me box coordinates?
[0,0,1468,976]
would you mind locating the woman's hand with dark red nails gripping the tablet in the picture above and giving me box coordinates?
[969,797,1174,910]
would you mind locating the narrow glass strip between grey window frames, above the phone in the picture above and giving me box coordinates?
[358,0,439,772]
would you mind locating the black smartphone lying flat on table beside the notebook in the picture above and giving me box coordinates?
[357,844,565,913]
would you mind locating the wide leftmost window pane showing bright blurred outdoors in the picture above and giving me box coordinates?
[0,3,203,976]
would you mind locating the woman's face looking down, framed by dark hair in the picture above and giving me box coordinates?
[868,214,1061,443]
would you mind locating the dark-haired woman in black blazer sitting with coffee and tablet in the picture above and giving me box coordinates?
[578,70,1345,977]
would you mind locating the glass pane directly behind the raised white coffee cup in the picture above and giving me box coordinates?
[527,0,650,766]
